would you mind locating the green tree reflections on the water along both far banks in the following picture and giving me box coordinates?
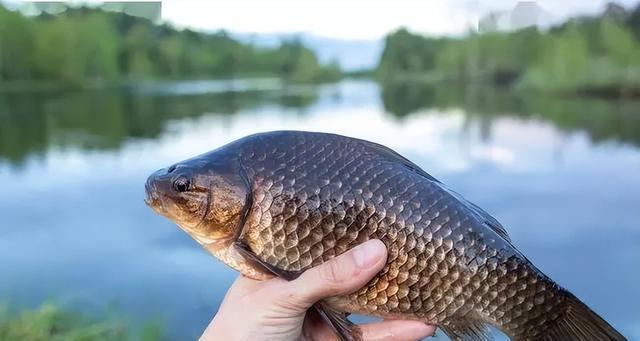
[5,79,640,165]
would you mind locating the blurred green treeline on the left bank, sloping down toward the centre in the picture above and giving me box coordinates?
[0,4,341,83]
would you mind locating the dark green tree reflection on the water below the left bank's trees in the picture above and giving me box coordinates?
[0,86,316,164]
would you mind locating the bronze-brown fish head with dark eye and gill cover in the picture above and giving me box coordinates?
[145,153,251,245]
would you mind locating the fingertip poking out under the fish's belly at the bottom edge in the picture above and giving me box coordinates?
[360,320,436,341]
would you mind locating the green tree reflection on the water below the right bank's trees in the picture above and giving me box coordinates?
[382,82,640,146]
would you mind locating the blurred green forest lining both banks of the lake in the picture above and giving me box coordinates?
[0,4,640,98]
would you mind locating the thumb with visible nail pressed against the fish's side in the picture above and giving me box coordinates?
[283,240,387,309]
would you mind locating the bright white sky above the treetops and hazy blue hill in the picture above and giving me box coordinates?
[162,0,638,40]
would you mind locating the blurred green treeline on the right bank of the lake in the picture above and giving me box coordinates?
[377,4,640,96]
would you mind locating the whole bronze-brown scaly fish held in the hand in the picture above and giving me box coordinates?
[145,131,625,341]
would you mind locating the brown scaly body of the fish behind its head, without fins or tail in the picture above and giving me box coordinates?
[234,134,576,340]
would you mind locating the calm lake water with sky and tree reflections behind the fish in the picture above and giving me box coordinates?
[0,80,640,339]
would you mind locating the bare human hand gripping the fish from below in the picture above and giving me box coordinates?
[200,240,436,341]
